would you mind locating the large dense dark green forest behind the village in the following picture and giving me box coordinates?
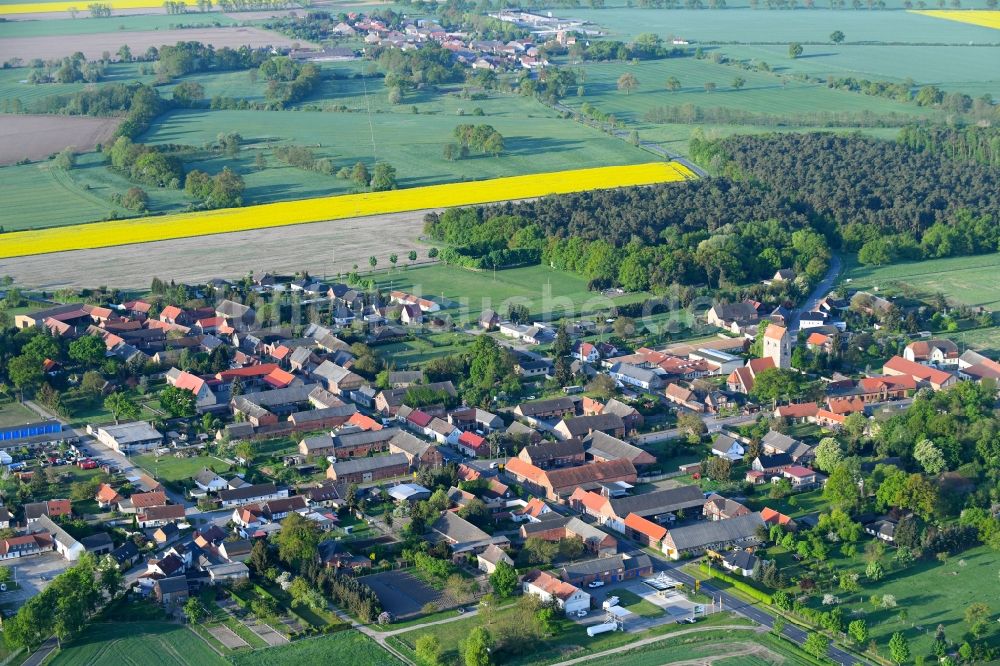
[425,128,1000,292]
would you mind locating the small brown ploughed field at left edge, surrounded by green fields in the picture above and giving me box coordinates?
[0,115,119,165]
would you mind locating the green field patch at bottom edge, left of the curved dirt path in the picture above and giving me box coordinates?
[229,630,401,666]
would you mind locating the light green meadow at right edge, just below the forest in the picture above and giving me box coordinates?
[844,253,1000,309]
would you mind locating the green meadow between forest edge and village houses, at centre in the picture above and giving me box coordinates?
[376,265,645,325]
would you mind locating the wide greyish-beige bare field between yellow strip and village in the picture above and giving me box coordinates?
[0,211,438,290]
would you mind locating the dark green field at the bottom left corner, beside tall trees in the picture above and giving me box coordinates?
[49,622,226,666]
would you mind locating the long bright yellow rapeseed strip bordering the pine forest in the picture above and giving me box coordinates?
[0,162,695,259]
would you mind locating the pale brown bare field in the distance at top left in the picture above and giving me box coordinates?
[0,27,311,62]
